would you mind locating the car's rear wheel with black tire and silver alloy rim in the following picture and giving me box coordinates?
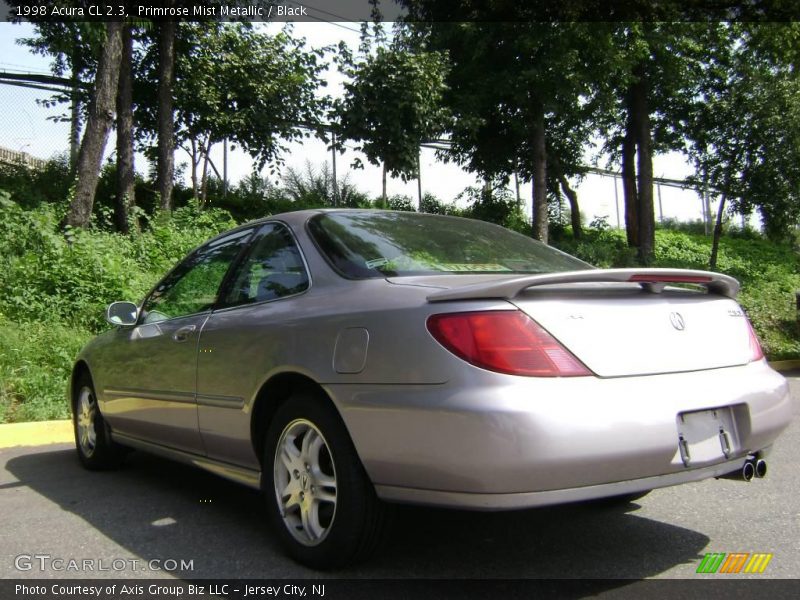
[261,392,386,569]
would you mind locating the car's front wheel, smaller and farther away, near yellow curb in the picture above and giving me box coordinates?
[72,372,125,471]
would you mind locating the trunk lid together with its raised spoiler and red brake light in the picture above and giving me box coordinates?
[390,269,752,377]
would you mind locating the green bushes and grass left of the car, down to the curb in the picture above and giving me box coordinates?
[0,191,236,422]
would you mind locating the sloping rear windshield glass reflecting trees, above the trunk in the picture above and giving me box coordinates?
[308,211,591,279]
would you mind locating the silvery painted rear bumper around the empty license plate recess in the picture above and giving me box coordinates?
[329,361,791,510]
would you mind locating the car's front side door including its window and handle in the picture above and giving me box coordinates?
[101,228,255,454]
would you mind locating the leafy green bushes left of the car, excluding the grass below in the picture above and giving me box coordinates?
[0,197,235,331]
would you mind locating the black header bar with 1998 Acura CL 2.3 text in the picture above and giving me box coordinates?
[0,0,800,22]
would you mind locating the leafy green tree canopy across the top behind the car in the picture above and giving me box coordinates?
[12,14,800,253]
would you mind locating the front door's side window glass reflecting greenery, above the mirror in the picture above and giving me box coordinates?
[143,229,253,323]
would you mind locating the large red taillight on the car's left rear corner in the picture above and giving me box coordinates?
[427,310,591,377]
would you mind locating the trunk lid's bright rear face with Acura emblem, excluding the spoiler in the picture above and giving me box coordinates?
[512,286,750,377]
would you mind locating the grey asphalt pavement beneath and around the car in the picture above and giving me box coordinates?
[0,373,800,579]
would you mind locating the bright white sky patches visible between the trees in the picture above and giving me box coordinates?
[0,22,720,227]
